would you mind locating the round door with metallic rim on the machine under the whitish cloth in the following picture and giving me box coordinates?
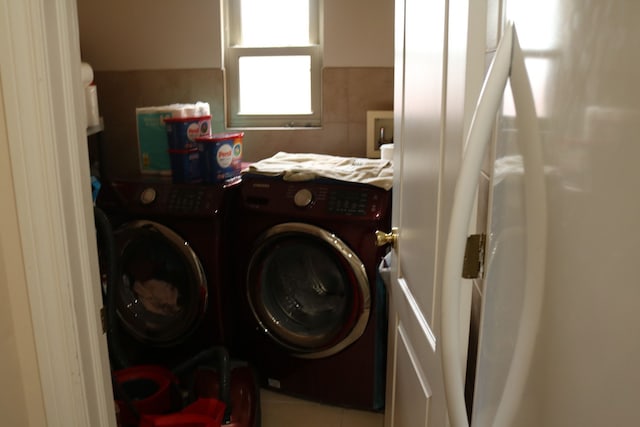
[247,223,371,358]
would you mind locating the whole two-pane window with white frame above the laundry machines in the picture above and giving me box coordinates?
[224,0,322,127]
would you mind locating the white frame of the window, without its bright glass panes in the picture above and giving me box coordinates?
[222,0,322,128]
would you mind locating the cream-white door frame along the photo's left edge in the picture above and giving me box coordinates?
[0,0,115,427]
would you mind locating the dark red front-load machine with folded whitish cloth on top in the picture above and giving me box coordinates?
[232,174,391,410]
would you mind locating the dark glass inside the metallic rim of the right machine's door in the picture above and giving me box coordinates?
[249,233,362,352]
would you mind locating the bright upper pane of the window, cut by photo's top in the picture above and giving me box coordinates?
[240,0,309,46]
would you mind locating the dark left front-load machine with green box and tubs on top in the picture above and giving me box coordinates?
[97,180,237,367]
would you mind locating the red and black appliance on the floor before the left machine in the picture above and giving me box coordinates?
[113,347,260,427]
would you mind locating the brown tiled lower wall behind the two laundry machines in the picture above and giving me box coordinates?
[95,68,393,178]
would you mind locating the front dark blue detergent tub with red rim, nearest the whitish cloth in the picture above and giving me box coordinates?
[196,132,244,183]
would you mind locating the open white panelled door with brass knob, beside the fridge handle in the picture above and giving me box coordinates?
[385,0,486,427]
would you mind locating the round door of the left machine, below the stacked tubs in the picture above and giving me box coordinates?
[114,221,207,347]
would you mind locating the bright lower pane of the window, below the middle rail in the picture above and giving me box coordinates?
[239,55,312,115]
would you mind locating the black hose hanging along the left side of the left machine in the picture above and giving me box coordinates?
[93,206,130,370]
